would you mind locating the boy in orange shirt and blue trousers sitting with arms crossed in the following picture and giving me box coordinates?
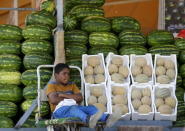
[46,63,121,128]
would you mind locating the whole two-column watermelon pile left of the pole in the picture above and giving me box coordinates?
[0,1,56,128]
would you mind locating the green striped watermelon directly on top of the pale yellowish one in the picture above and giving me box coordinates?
[0,54,22,70]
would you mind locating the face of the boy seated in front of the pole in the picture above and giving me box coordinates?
[55,68,70,84]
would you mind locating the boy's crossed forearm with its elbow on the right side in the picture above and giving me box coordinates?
[58,93,83,103]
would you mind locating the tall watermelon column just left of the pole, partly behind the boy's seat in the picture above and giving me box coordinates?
[21,1,56,127]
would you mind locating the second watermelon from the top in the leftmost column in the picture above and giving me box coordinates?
[0,40,21,55]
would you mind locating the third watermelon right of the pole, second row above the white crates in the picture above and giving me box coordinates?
[119,30,146,46]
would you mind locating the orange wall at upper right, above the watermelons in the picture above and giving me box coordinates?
[103,0,159,33]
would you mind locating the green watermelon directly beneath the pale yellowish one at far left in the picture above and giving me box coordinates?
[0,85,22,102]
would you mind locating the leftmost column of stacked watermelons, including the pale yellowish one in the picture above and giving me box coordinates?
[0,25,22,128]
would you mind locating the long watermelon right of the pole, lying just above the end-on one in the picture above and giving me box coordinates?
[69,5,104,20]
